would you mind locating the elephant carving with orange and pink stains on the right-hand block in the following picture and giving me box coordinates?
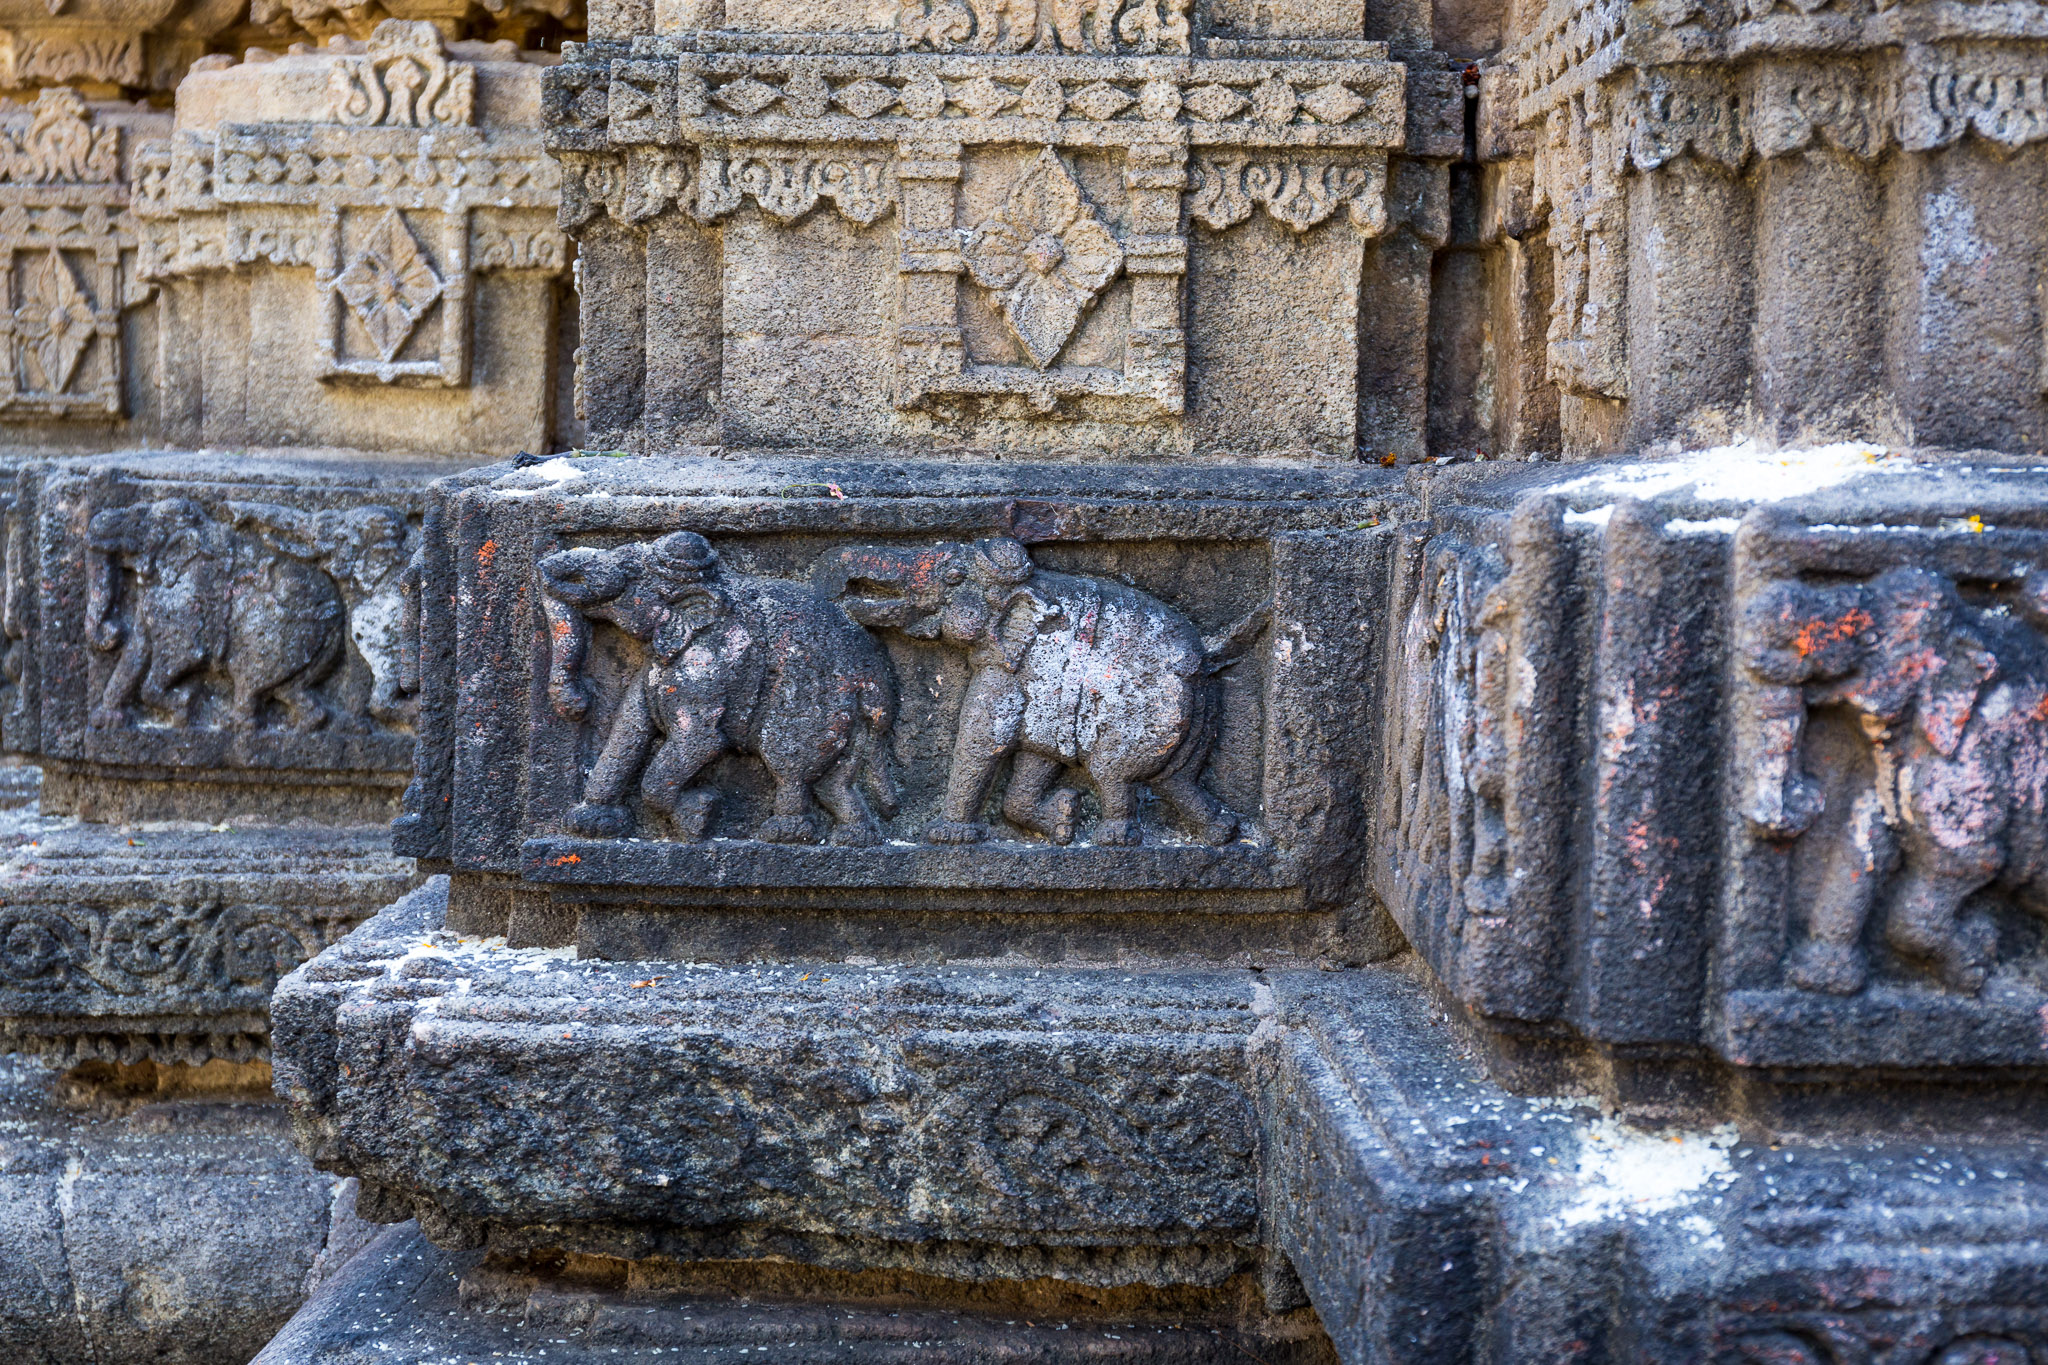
[1741,569,2048,995]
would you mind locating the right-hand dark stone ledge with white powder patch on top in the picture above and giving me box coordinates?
[1260,970,2048,1365]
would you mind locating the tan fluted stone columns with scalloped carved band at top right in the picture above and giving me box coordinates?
[1485,0,2048,450]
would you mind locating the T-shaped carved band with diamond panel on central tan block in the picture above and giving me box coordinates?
[547,42,1405,435]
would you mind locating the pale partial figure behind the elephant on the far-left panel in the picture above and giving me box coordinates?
[227,501,418,722]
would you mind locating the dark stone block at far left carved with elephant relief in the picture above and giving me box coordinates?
[4,456,450,817]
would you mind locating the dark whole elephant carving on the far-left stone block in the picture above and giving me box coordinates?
[86,497,344,731]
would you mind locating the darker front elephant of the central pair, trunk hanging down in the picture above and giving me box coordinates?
[541,530,897,845]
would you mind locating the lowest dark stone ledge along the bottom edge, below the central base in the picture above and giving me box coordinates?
[256,1226,1331,1365]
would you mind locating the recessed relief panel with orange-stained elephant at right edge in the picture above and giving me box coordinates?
[1731,512,2048,1017]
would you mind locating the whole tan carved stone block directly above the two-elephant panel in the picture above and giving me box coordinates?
[547,24,1427,460]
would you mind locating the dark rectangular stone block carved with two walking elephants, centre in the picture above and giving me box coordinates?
[401,460,1384,933]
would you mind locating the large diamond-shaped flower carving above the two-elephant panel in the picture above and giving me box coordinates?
[965,147,1124,370]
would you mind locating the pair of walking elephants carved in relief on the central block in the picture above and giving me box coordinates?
[539,532,1270,847]
